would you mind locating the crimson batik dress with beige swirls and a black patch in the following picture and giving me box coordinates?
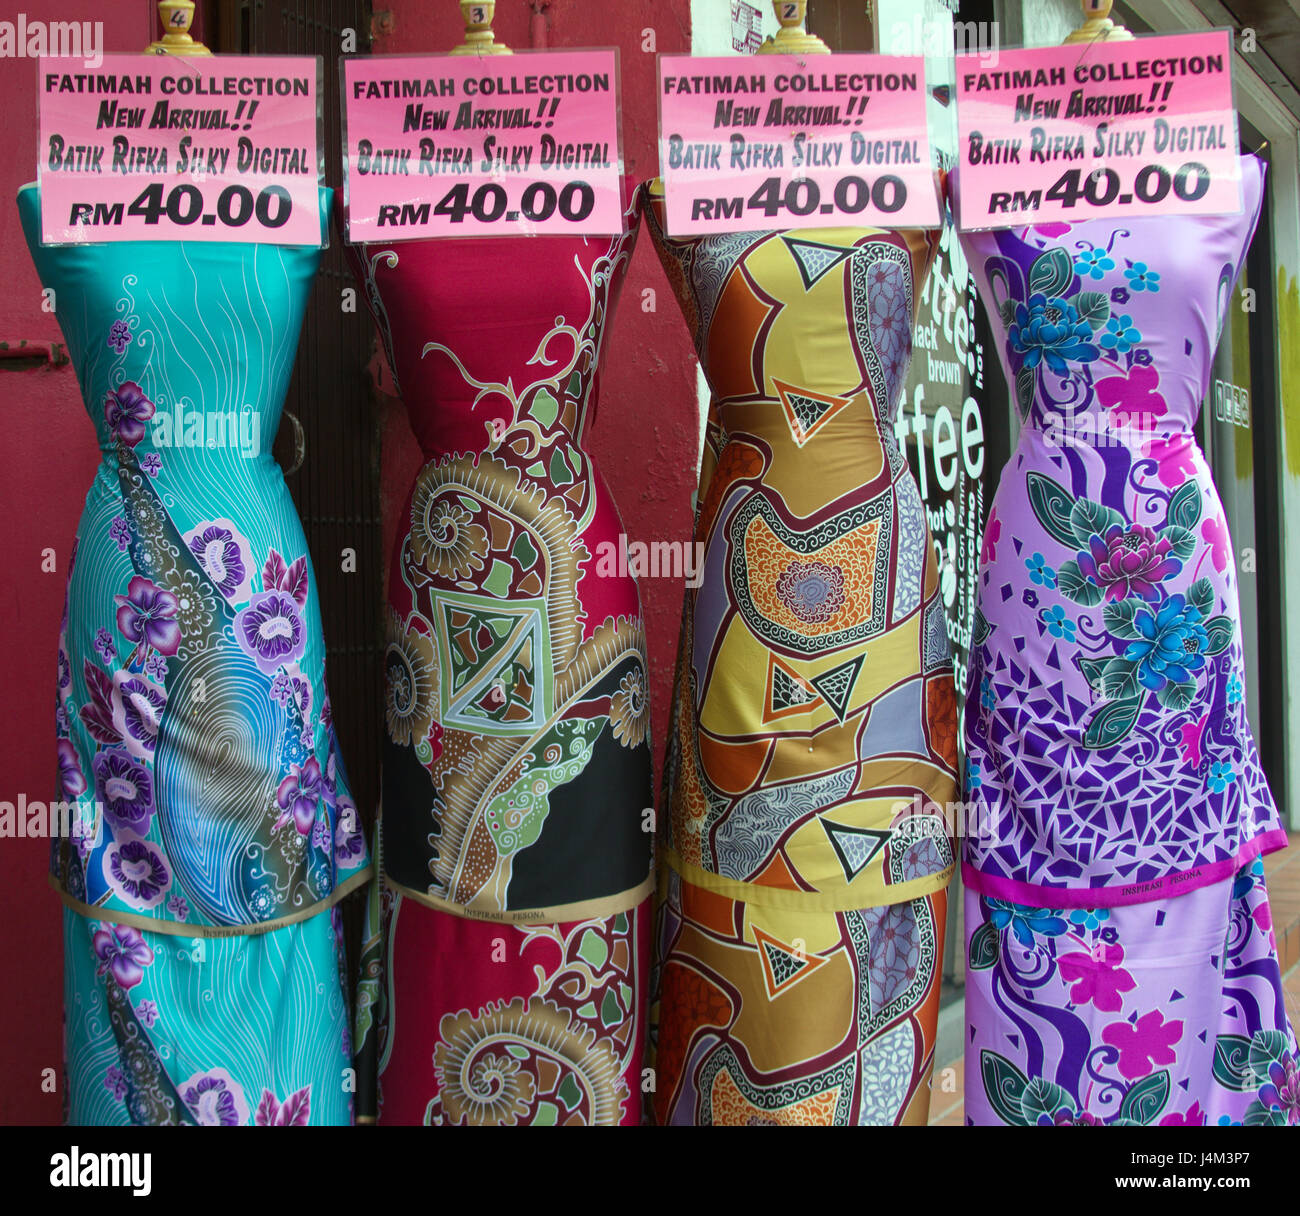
[351,183,654,1125]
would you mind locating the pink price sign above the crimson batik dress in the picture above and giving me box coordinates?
[343,49,623,245]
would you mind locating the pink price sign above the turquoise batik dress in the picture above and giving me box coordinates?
[38,55,321,246]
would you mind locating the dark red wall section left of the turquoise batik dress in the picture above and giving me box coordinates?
[0,0,153,1124]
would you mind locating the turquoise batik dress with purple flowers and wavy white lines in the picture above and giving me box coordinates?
[18,186,369,1125]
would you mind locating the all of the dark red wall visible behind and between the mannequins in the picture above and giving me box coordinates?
[0,0,697,1124]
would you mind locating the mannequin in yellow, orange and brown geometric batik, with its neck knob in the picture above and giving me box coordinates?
[644,4,957,1124]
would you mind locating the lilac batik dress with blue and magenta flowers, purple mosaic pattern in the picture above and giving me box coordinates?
[957,157,1300,1124]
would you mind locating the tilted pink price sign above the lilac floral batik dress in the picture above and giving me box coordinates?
[956,30,1242,229]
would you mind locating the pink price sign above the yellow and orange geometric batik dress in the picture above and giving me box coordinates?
[659,55,939,237]
